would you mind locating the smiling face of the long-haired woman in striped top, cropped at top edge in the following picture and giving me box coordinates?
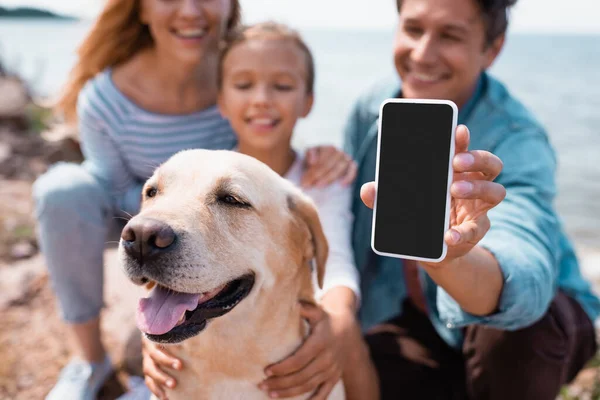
[140,0,232,64]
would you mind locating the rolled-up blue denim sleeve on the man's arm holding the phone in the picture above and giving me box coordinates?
[437,132,560,330]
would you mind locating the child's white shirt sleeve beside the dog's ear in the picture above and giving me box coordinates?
[311,183,360,303]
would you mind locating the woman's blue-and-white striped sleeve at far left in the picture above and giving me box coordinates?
[77,86,143,212]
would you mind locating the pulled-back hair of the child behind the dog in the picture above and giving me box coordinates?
[218,21,315,94]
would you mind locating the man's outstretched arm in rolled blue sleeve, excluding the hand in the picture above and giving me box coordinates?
[436,132,559,329]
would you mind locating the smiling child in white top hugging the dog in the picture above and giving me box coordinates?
[139,23,378,399]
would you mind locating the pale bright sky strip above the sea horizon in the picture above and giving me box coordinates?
[0,0,600,34]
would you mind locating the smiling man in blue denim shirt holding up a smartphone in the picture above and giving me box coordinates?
[345,0,600,400]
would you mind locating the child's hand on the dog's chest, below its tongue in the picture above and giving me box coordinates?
[142,338,183,400]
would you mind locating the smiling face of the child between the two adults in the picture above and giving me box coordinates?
[219,39,313,150]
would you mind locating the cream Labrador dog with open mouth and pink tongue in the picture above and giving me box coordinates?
[119,150,345,400]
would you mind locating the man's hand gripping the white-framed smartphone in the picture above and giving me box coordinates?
[360,125,506,268]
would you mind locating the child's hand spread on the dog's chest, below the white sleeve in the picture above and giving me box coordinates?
[259,303,360,400]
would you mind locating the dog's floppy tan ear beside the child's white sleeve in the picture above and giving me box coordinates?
[288,193,329,289]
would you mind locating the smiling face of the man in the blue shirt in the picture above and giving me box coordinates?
[394,0,504,107]
